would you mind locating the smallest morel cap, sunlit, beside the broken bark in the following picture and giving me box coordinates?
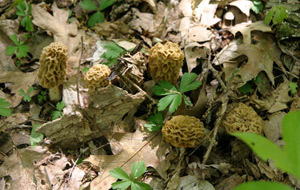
[84,64,111,92]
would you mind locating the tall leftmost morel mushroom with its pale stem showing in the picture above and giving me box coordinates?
[38,42,68,102]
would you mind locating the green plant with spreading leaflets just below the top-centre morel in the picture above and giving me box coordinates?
[152,73,201,113]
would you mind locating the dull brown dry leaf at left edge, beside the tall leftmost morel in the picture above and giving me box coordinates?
[0,71,37,107]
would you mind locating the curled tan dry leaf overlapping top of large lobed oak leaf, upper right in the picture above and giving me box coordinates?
[229,21,272,44]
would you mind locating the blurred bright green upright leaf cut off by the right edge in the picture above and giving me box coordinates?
[282,111,300,179]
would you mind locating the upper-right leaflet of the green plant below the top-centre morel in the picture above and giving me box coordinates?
[179,73,201,93]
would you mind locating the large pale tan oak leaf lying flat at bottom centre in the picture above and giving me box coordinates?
[84,128,161,190]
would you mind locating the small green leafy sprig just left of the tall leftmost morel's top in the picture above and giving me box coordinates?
[5,34,29,64]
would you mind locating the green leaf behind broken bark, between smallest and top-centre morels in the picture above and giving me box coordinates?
[101,42,125,66]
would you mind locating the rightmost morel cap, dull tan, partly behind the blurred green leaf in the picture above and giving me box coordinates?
[222,103,262,134]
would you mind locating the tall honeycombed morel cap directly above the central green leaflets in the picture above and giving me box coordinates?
[149,42,184,84]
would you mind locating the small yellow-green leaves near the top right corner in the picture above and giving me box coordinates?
[265,5,288,26]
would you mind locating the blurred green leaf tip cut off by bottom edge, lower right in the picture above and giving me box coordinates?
[233,181,293,190]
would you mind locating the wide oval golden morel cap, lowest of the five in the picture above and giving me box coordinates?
[162,115,204,148]
